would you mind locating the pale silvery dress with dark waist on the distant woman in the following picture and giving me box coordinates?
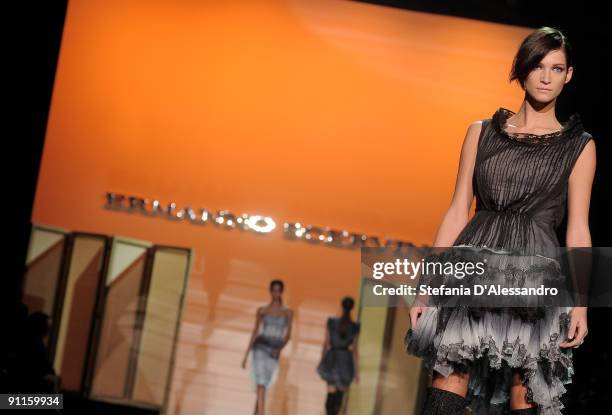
[251,314,289,387]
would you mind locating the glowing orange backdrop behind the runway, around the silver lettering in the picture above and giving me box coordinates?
[32,0,528,414]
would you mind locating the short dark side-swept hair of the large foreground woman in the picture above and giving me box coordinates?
[510,26,572,89]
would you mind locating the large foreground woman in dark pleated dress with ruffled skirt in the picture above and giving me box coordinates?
[406,27,596,415]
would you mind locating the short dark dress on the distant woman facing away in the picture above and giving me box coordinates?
[317,317,360,389]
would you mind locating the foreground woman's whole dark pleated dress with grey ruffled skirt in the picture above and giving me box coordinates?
[405,107,592,415]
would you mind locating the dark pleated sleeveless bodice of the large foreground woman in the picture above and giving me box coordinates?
[453,107,592,254]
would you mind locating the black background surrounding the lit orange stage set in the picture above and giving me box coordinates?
[2,0,612,414]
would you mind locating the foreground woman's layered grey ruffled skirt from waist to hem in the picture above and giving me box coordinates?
[405,247,574,415]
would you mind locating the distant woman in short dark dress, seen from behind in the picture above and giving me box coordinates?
[317,297,360,415]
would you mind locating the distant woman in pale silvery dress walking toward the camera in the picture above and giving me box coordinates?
[242,280,293,415]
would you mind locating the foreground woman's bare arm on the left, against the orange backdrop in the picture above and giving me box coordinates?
[411,121,482,314]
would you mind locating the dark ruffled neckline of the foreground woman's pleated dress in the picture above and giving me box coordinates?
[492,107,583,144]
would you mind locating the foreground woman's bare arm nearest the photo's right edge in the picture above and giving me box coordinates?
[560,140,596,347]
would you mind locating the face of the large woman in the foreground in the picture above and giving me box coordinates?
[525,50,573,102]
